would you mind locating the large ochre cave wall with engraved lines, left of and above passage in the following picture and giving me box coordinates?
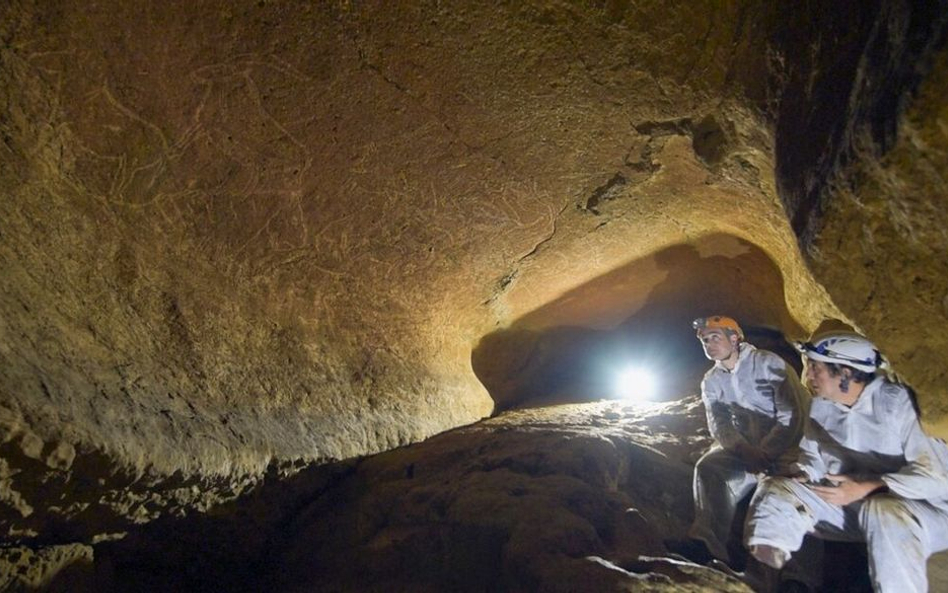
[0,2,835,539]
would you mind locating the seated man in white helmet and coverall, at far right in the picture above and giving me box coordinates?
[745,333,948,593]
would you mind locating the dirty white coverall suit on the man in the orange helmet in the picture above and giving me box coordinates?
[688,343,809,561]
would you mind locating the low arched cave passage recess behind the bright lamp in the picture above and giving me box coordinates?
[472,234,803,411]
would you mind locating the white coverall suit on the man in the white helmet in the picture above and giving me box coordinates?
[745,377,948,593]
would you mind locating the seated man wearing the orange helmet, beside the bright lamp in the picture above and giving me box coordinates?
[670,315,809,570]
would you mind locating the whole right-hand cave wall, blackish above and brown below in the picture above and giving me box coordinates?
[775,2,948,426]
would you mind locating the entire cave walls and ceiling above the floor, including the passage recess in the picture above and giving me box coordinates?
[0,0,948,584]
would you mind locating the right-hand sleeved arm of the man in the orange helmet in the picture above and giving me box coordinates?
[758,365,810,459]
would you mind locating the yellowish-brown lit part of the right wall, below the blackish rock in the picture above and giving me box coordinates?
[796,51,948,426]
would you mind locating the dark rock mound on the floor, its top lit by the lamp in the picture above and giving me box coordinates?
[270,401,712,591]
